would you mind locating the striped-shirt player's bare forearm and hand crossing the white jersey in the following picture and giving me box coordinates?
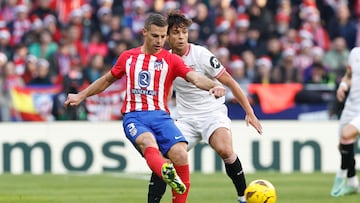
[186,71,226,98]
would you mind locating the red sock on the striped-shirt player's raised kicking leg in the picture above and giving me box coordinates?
[144,147,165,177]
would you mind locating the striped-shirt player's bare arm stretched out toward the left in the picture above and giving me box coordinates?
[64,71,117,108]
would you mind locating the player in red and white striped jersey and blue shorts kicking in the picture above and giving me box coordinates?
[64,14,226,203]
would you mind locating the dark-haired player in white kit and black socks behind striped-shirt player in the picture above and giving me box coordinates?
[148,11,262,203]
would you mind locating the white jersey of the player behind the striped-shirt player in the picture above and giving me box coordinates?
[174,44,225,117]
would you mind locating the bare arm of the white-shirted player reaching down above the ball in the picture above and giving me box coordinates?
[218,71,263,134]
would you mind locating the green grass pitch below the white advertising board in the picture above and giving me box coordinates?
[0,172,360,203]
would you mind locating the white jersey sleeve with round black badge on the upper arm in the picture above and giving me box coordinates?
[199,48,225,78]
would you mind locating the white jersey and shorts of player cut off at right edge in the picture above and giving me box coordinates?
[340,47,360,130]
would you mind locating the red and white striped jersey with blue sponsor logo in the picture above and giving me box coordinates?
[111,47,191,114]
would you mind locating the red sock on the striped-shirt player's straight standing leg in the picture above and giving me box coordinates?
[172,165,190,203]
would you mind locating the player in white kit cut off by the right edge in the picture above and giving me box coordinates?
[331,47,360,197]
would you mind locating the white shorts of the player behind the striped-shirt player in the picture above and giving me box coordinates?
[175,105,231,150]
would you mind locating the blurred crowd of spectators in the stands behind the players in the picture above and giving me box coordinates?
[0,0,360,121]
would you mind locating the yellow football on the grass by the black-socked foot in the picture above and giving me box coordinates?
[245,179,276,203]
